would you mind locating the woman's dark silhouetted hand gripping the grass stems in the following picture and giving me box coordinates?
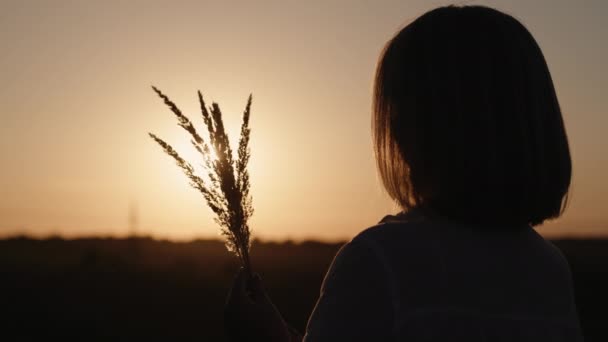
[224,269,297,342]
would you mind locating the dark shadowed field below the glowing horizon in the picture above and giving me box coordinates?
[0,238,608,341]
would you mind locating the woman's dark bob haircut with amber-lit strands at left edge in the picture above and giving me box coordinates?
[372,6,572,226]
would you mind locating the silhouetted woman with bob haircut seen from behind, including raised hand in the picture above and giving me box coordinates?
[226,6,582,342]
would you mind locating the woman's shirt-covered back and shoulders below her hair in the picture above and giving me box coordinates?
[305,215,582,341]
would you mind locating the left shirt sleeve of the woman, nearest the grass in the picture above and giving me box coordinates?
[303,239,394,342]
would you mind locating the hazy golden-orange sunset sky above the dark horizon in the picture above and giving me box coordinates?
[0,0,608,240]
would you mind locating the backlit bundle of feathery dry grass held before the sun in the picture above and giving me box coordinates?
[149,86,253,274]
